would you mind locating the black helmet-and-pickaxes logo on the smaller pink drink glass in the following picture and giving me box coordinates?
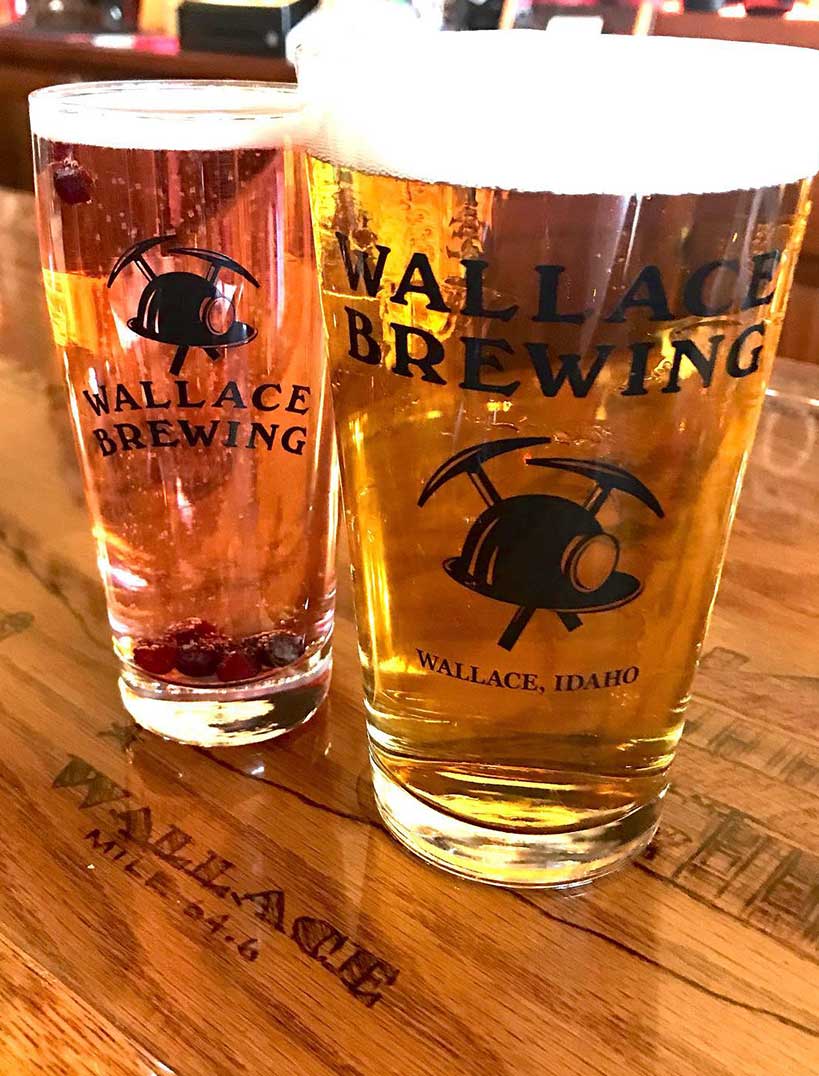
[108,235,259,376]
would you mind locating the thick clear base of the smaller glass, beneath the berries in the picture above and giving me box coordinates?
[119,641,333,747]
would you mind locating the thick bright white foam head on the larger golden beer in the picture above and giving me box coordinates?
[297,30,819,195]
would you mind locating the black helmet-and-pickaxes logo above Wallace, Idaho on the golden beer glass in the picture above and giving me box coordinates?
[418,437,663,650]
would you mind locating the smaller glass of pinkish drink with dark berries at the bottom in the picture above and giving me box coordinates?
[31,82,337,745]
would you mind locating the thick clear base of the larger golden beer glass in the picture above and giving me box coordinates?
[372,761,665,888]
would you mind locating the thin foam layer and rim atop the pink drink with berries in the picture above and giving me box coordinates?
[29,81,302,150]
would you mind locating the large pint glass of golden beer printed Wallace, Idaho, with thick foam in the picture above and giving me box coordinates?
[299,31,819,886]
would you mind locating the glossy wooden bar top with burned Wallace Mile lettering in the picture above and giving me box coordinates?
[0,193,819,1076]
